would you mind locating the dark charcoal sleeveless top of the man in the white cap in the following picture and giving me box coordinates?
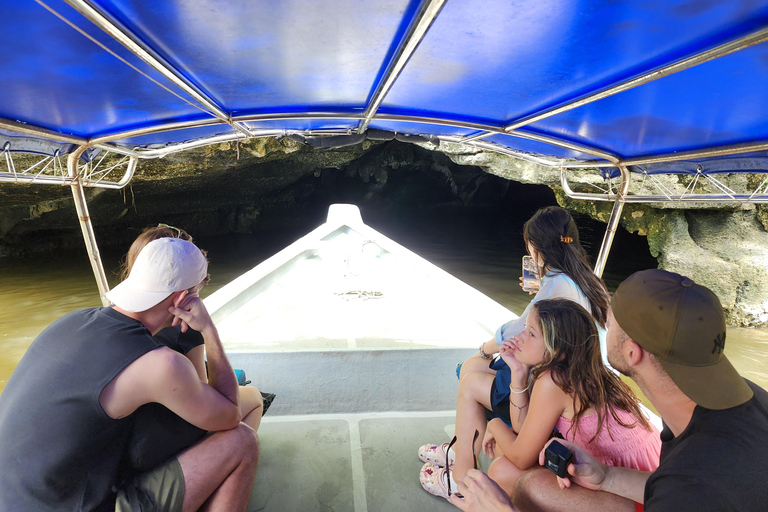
[0,308,160,512]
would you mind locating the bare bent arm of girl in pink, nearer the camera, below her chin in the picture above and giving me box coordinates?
[488,372,572,470]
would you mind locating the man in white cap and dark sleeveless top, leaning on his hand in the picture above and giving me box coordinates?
[0,238,258,511]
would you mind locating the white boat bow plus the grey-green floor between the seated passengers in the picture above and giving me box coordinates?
[205,205,515,512]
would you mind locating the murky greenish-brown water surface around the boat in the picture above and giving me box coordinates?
[0,213,768,392]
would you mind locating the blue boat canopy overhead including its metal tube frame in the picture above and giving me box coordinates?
[0,0,768,302]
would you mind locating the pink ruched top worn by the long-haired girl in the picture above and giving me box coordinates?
[555,409,661,471]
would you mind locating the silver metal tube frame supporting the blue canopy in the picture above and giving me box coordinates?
[0,0,768,305]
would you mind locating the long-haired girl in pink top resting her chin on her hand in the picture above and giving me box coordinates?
[483,299,661,494]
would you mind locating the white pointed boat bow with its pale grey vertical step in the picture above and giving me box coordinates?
[205,205,516,414]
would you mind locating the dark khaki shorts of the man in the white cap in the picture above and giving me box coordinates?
[115,457,184,512]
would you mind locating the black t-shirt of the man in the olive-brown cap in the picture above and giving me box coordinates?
[645,381,768,512]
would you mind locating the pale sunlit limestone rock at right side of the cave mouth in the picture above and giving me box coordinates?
[425,144,768,327]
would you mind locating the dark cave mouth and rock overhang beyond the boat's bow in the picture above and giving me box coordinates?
[0,138,510,257]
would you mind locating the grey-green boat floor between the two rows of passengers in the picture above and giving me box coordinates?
[248,411,457,512]
